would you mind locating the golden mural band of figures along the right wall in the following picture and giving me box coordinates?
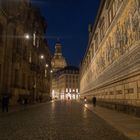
[86,0,140,81]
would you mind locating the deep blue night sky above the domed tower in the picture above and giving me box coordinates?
[32,0,100,66]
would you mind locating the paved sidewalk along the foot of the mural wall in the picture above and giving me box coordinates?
[84,103,140,140]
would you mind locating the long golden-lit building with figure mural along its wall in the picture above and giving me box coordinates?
[80,0,140,112]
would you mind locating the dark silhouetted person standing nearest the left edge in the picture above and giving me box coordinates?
[2,95,9,112]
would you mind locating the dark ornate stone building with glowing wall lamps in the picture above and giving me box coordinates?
[0,0,51,104]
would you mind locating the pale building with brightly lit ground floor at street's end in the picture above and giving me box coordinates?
[52,66,80,100]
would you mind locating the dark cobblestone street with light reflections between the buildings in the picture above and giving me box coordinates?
[0,101,128,140]
